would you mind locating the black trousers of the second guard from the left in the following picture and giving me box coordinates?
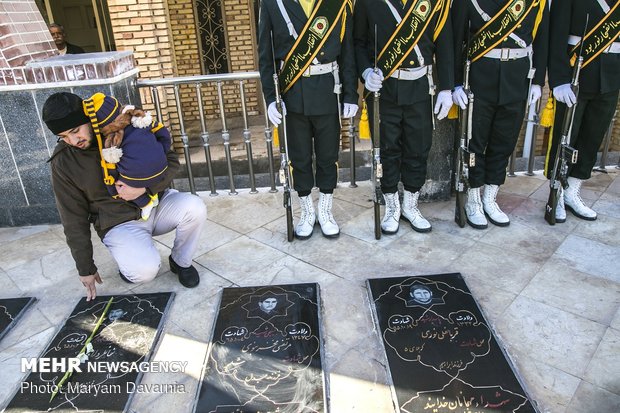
[368,94,433,193]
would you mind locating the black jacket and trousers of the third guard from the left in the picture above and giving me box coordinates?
[452,0,549,188]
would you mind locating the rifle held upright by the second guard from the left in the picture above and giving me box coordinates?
[371,26,383,239]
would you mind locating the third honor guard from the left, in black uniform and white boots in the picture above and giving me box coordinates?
[452,0,549,229]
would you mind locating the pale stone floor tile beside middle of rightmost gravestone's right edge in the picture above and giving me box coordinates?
[495,296,606,377]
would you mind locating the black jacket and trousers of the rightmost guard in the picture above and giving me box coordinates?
[547,0,620,179]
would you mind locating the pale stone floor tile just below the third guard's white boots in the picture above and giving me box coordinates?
[451,243,542,294]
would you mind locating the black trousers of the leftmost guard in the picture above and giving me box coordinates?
[280,112,340,196]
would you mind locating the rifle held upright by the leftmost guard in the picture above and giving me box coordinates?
[271,33,295,242]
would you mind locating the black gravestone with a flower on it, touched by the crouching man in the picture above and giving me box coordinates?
[6,293,174,413]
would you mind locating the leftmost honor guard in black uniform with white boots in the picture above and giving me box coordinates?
[258,0,358,239]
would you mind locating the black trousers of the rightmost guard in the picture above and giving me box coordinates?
[547,90,618,179]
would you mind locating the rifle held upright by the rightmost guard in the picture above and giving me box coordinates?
[545,14,590,225]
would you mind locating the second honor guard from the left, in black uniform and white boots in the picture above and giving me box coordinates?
[353,0,454,234]
